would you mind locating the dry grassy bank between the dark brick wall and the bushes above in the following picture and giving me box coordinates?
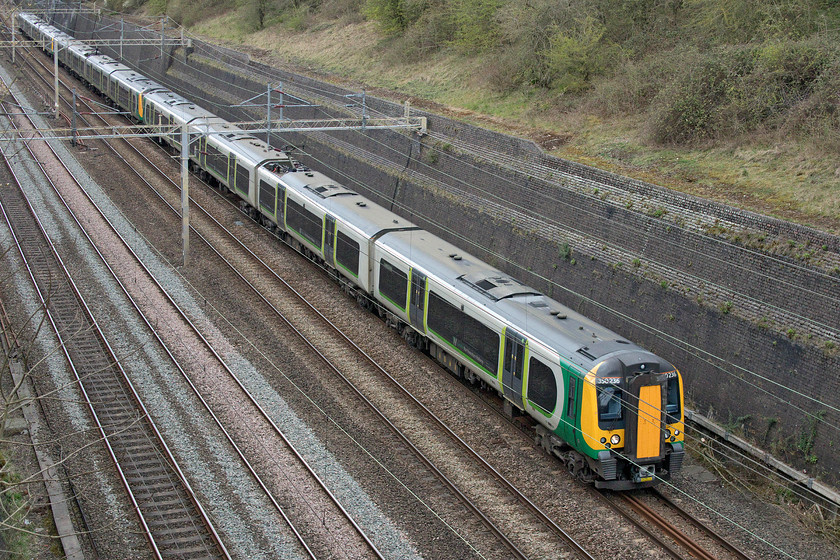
[185,12,840,233]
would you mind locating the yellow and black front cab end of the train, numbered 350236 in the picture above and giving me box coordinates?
[580,352,685,490]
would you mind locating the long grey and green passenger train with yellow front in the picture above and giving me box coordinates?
[17,12,685,490]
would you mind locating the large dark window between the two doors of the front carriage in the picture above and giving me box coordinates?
[427,291,499,376]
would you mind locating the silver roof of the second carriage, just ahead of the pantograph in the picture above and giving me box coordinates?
[280,169,417,238]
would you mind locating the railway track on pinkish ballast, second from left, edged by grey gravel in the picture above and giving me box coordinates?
[6,40,394,558]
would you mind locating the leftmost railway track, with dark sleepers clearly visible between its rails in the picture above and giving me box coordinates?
[0,85,230,558]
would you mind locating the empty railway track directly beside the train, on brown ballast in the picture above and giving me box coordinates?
[13,23,612,558]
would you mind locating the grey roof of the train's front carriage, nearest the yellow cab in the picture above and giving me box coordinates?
[377,230,646,369]
